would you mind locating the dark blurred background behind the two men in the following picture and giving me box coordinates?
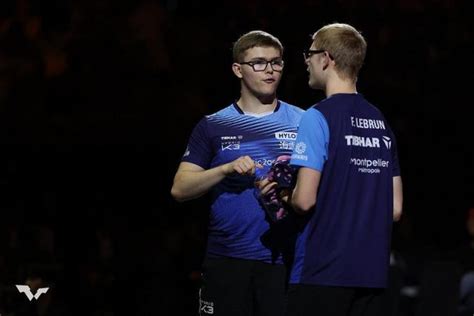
[0,0,474,316]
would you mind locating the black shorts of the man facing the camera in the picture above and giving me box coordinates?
[199,258,286,316]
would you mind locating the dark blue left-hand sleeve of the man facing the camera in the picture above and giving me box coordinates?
[181,118,213,169]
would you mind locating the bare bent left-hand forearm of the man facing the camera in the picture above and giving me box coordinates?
[171,166,226,202]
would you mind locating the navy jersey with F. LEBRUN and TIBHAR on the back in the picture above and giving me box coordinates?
[290,94,400,287]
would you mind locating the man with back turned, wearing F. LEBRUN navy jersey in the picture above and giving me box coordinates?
[261,23,402,316]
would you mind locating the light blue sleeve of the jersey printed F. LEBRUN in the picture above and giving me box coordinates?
[290,108,329,171]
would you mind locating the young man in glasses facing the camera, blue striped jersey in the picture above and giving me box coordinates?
[171,31,303,316]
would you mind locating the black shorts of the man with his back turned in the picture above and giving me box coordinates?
[285,284,386,316]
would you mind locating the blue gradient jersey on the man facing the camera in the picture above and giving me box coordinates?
[182,101,304,262]
